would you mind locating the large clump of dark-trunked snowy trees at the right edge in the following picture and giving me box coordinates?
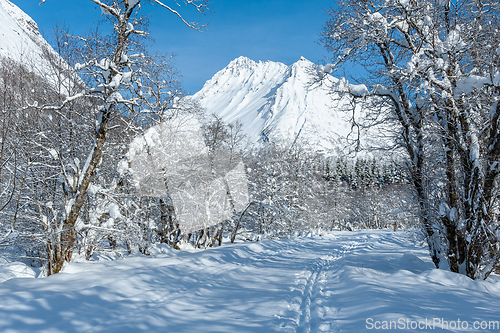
[322,0,500,279]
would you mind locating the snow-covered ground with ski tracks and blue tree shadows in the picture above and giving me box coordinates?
[0,231,500,332]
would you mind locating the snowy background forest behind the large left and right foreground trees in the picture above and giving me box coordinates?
[0,47,415,273]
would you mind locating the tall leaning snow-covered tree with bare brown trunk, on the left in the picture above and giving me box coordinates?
[31,0,207,274]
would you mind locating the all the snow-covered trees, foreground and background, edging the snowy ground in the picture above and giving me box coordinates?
[0,0,500,279]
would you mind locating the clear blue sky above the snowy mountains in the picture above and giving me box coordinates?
[11,0,334,93]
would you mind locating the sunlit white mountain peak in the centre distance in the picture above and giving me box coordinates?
[189,57,370,153]
